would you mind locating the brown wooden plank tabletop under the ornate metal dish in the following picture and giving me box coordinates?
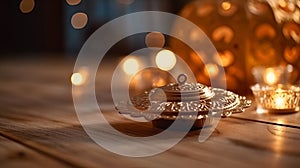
[0,59,300,168]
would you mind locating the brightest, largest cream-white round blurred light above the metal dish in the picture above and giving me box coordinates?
[155,50,176,71]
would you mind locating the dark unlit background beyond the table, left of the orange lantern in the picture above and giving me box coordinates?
[0,0,188,57]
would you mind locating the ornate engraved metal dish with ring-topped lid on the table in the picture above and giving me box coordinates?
[117,83,251,120]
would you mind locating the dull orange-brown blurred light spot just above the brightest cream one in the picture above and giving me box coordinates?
[145,32,166,48]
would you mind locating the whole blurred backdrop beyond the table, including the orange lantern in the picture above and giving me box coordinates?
[0,0,300,94]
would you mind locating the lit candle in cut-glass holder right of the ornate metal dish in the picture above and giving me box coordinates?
[251,65,300,113]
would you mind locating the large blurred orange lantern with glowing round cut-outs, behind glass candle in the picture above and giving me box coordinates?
[170,0,300,94]
